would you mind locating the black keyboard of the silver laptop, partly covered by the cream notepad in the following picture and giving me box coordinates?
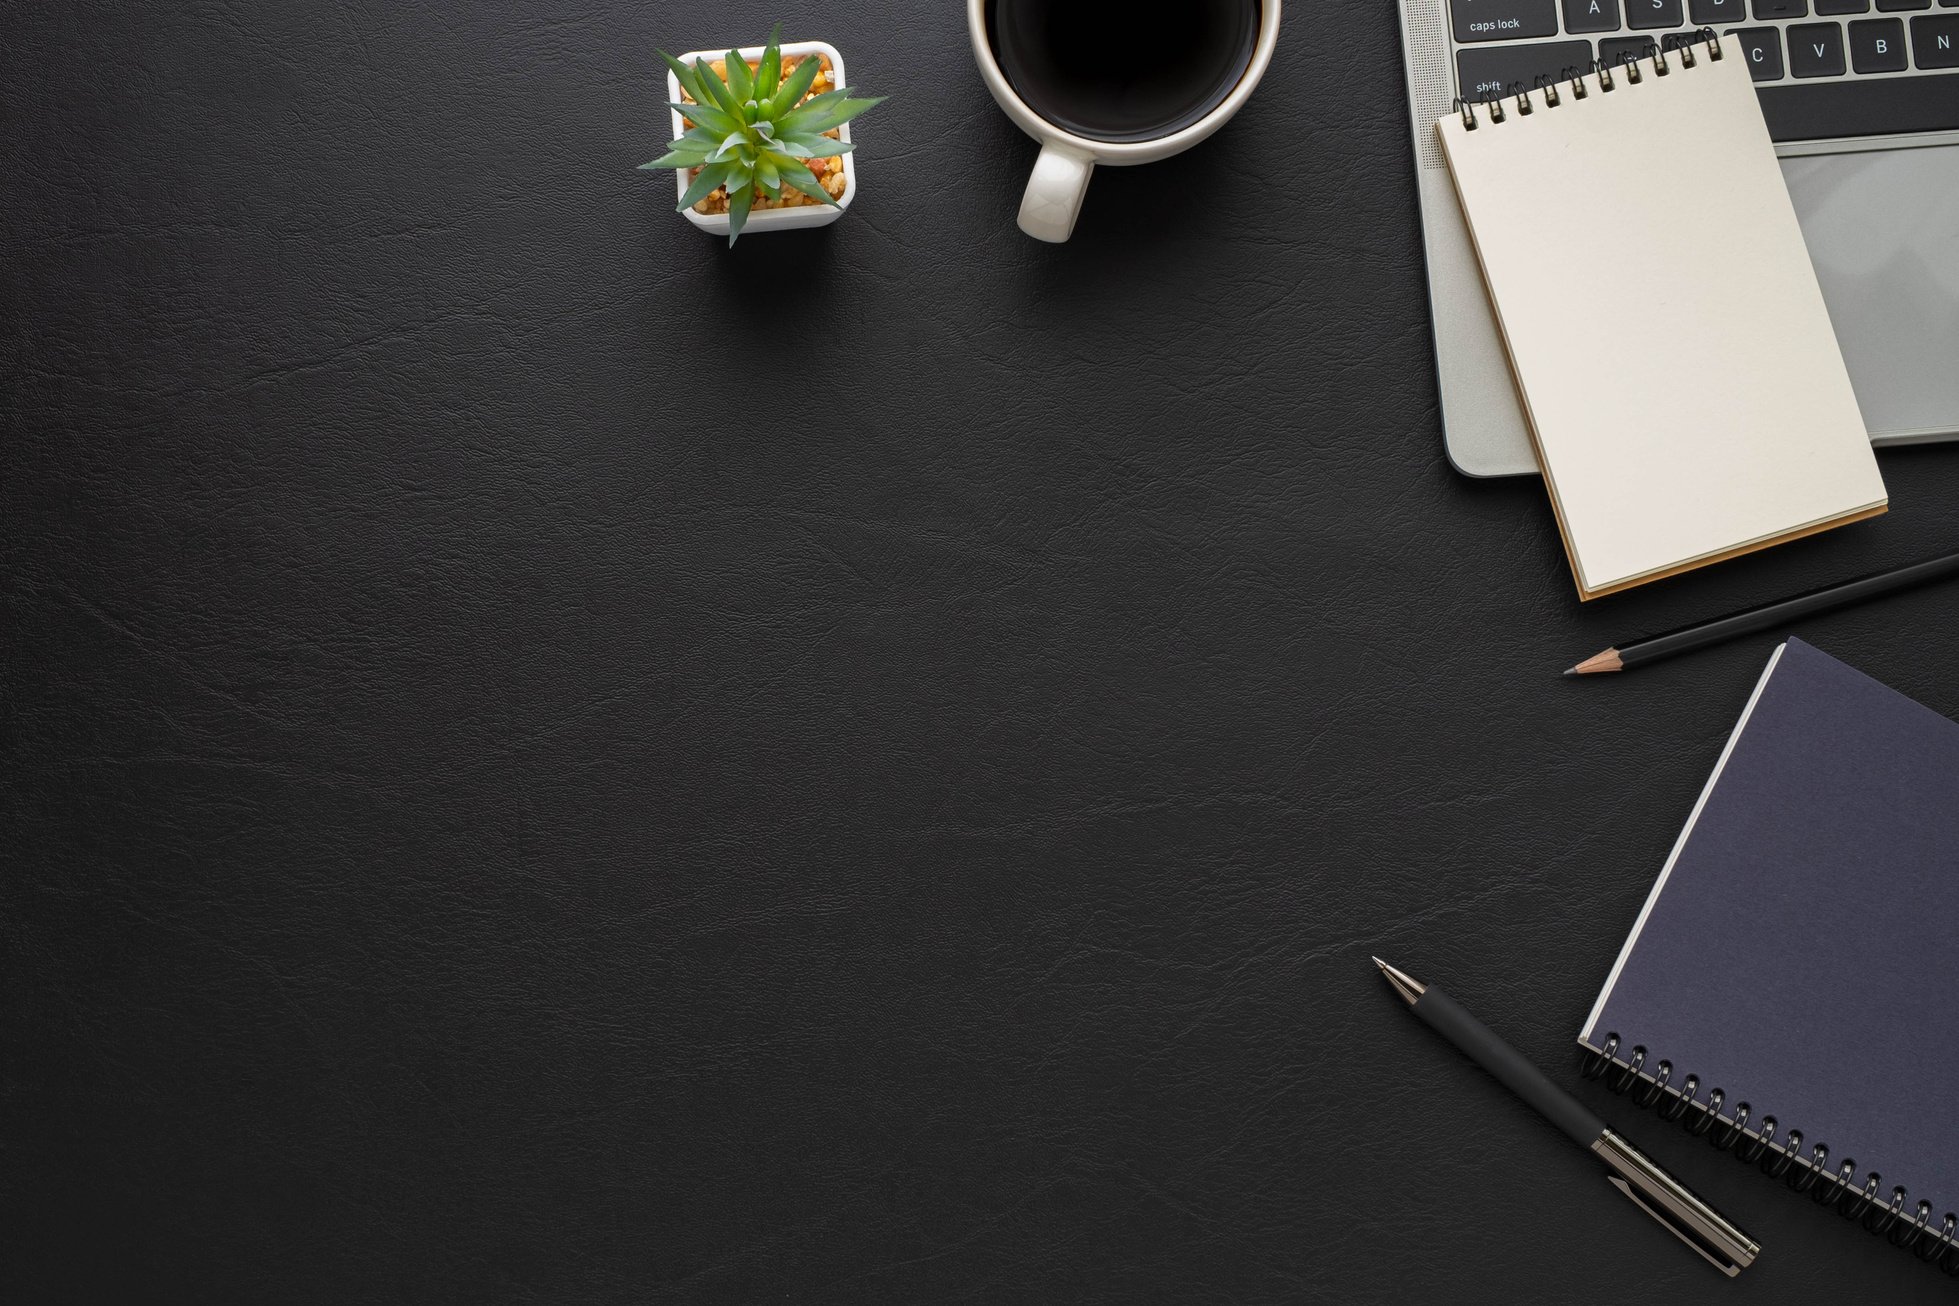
[1450,0,1959,141]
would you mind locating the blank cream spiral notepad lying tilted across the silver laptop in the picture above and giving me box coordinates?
[1436,37,1887,599]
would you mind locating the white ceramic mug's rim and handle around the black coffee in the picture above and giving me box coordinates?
[966,0,1279,243]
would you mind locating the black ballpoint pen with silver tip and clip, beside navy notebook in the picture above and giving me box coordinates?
[1373,957,1761,1277]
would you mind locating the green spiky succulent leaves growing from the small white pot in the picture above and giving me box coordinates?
[639,23,878,245]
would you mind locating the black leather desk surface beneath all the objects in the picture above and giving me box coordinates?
[0,0,1959,1304]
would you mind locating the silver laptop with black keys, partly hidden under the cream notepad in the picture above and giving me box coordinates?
[1399,0,1959,476]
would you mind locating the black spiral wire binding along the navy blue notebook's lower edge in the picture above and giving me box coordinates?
[1583,1034,1959,1275]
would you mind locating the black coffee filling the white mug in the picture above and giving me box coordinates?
[985,0,1262,141]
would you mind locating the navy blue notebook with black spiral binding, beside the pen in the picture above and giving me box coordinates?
[1579,640,1959,1251]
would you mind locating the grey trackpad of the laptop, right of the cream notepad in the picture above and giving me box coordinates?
[1786,145,1959,441]
